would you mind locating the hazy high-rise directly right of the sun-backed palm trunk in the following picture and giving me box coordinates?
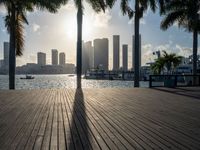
[82,41,94,73]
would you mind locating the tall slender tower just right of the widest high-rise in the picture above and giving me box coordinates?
[113,35,120,70]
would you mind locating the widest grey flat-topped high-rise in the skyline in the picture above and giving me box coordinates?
[94,38,108,70]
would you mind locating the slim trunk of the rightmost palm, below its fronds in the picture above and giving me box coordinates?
[193,30,198,75]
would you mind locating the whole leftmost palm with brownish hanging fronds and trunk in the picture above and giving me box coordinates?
[0,0,65,89]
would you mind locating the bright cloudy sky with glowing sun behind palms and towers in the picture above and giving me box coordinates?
[0,0,200,68]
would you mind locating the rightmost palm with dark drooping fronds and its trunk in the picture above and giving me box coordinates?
[161,0,200,75]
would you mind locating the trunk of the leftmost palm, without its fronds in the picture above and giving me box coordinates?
[9,4,16,90]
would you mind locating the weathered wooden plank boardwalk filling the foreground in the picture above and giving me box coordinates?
[0,88,200,150]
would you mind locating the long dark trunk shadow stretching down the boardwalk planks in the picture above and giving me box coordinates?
[69,88,91,150]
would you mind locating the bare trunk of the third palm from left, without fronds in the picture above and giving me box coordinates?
[134,0,140,87]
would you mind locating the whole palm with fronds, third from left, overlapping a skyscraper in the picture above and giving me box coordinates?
[115,0,167,87]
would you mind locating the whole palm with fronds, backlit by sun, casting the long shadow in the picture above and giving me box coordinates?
[74,0,113,88]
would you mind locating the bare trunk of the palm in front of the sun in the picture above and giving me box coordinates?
[76,4,83,88]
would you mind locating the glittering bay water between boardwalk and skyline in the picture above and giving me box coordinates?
[0,75,148,89]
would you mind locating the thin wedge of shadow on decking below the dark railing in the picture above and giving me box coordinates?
[152,88,200,100]
